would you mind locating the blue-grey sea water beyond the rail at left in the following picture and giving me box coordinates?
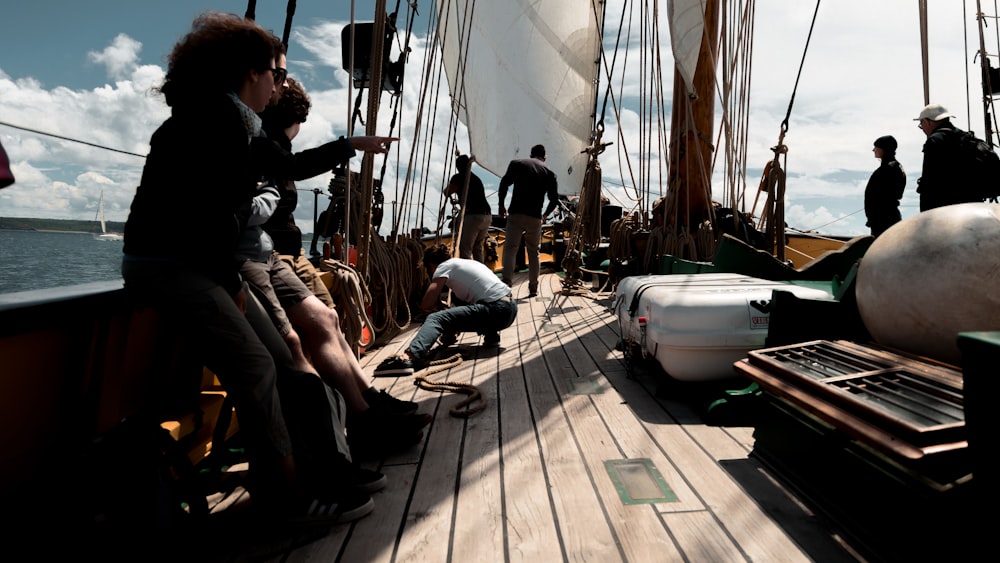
[0,230,122,293]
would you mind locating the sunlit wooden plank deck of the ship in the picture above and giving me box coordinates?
[170,273,884,562]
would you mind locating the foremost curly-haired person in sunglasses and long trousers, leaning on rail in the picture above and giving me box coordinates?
[122,12,372,523]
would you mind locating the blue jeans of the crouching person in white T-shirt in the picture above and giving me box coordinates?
[409,294,517,360]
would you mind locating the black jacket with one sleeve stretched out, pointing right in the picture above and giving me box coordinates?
[263,128,355,256]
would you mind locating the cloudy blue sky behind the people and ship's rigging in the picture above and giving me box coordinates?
[0,0,988,235]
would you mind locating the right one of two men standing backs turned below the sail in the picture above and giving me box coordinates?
[499,145,559,297]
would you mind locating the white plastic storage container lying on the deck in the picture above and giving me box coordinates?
[614,274,833,381]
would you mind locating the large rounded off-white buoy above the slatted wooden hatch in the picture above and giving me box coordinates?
[856,203,1000,366]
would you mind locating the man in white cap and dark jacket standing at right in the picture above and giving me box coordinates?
[914,104,982,211]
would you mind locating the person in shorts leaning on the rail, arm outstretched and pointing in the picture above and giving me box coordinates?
[242,75,430,454]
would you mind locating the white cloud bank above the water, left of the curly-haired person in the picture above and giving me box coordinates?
[0,35,169,221]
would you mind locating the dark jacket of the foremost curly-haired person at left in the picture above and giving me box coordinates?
[123,95,257,293]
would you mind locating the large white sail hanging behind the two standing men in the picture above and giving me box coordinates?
[438,0,601,193]
